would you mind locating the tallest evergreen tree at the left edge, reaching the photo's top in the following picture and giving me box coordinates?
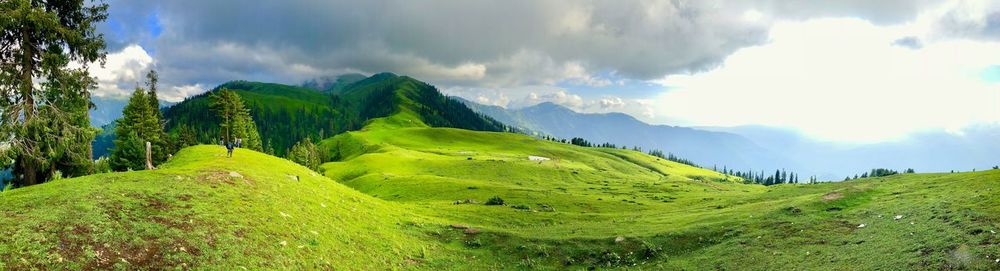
[0,0,107,186]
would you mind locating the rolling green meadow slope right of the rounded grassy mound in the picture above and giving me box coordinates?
[322,112,1000,270]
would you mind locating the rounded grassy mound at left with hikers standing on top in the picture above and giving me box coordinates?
[0,146,496,270]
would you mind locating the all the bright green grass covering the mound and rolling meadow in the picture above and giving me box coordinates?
[0,116,1000,270]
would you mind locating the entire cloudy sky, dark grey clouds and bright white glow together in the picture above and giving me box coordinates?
[92,0,1000,142]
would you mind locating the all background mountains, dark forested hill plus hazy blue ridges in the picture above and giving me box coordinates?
[91,73,1000,180]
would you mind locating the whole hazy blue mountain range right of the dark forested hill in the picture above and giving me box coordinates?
[453,97,1000,180]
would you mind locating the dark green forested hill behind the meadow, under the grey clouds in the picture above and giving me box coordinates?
[164,73,506,155]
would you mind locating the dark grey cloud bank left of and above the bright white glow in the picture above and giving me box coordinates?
[95,0,960,101]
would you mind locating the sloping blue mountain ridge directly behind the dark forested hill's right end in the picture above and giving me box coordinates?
[461,100,798,170]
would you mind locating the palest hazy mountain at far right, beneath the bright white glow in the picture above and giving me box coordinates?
[699,124,1000,179]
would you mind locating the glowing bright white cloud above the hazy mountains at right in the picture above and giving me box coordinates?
[656,19,1000,141]
